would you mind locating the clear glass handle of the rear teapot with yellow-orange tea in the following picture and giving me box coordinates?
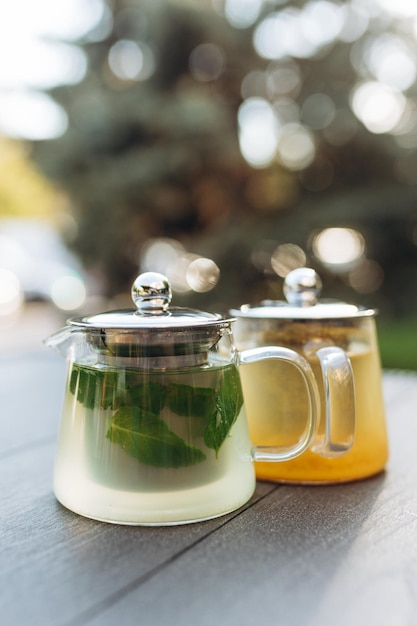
[313,347,355,457]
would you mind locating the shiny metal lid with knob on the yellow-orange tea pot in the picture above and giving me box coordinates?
[230,267,375,320]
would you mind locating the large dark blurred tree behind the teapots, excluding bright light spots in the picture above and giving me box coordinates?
[33,0,417,313]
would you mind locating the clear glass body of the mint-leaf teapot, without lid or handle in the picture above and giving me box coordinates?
[54,336,255,525]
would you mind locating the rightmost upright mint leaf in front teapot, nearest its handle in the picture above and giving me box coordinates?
[204,366,243,455]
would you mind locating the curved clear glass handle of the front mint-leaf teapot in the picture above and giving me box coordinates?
[239,346,320,461]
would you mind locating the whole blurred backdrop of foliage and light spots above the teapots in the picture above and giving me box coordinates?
[0,0,417,368]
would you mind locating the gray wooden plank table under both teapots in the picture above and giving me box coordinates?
[0,349,417,626]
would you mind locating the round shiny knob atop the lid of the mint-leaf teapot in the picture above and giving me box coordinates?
[131,272,172,315]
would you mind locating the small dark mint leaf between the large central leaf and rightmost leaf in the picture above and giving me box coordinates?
[166,383,216,419]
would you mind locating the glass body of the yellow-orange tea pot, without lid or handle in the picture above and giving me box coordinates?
[234,317,388,483]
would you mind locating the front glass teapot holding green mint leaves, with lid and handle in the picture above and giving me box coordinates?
[46,272,320,525]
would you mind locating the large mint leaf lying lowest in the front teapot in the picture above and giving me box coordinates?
[106,407,206,468]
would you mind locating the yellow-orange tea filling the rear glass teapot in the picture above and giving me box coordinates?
[240,346,388,483]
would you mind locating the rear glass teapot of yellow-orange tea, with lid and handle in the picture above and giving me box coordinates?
[230,268,388,484]
